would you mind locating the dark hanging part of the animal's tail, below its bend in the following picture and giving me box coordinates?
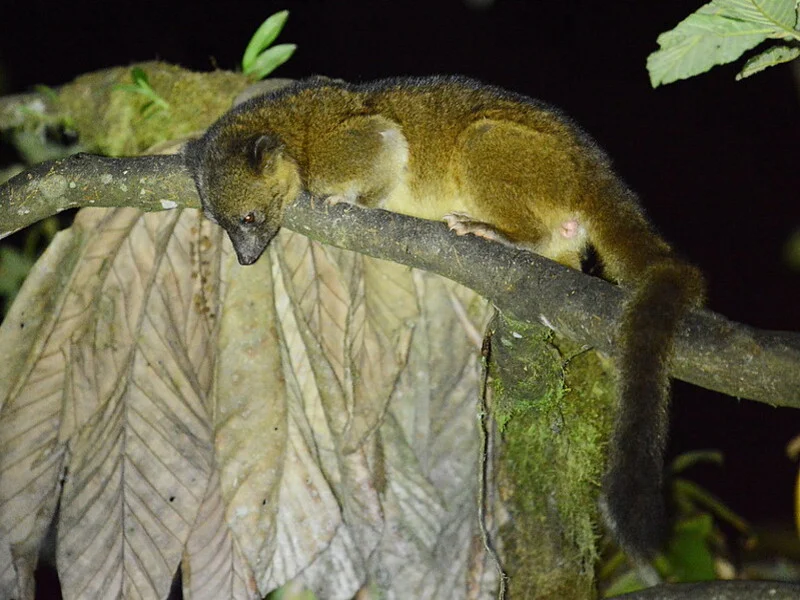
[603,259,703,560]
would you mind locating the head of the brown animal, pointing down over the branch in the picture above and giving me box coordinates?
[184,127,302,265]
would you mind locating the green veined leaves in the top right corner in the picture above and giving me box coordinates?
[647,0,800,87]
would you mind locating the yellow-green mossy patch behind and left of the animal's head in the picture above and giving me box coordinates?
[59,62,250,156]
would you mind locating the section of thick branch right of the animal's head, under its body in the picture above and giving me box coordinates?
[285,195,800,407]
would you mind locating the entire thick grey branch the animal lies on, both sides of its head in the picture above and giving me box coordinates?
[0,155,800,407]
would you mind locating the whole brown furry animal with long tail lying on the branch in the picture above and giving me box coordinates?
[185,77,703,556]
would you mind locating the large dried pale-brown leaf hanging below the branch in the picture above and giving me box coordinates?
[0,209,496,598]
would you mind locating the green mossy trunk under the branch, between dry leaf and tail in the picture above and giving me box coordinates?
[491,316,614,598]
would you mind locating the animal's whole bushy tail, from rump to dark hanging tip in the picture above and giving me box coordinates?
[592,183,704,559]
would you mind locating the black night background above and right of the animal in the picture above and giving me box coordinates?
[0,0,800,548]
